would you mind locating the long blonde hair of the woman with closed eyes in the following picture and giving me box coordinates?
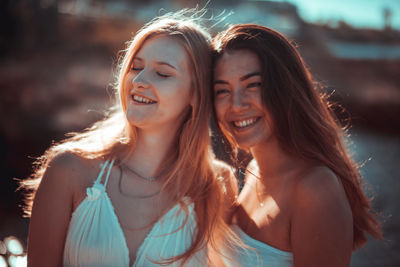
[21,9,231,265]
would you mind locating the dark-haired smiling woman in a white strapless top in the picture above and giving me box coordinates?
[214,24,381,267]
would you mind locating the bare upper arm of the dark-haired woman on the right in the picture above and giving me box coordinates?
[291,167,353,267]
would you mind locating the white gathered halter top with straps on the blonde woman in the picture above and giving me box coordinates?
[63,160,207,267]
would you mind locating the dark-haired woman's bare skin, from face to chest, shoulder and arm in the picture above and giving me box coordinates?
[214,49,353,267]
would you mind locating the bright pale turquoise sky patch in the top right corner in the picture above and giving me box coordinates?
[264,0,400,30]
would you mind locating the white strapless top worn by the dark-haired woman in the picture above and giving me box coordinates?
[224,224,293,267]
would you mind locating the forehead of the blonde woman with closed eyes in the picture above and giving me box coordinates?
[135,36,188,68]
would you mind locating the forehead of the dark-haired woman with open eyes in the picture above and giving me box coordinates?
[215,49,261,78]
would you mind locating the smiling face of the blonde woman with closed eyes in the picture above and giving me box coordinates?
[124,36,191,133]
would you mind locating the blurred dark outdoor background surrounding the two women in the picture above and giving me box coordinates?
[0,0,400,266]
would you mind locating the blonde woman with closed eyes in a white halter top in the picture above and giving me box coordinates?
[23,9,234,266]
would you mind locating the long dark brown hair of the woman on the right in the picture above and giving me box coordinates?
[214,24,382,249]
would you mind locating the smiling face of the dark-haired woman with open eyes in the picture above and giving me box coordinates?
[214,50,271,149]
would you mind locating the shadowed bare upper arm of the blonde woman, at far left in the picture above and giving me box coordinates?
[28,154,82,266]
